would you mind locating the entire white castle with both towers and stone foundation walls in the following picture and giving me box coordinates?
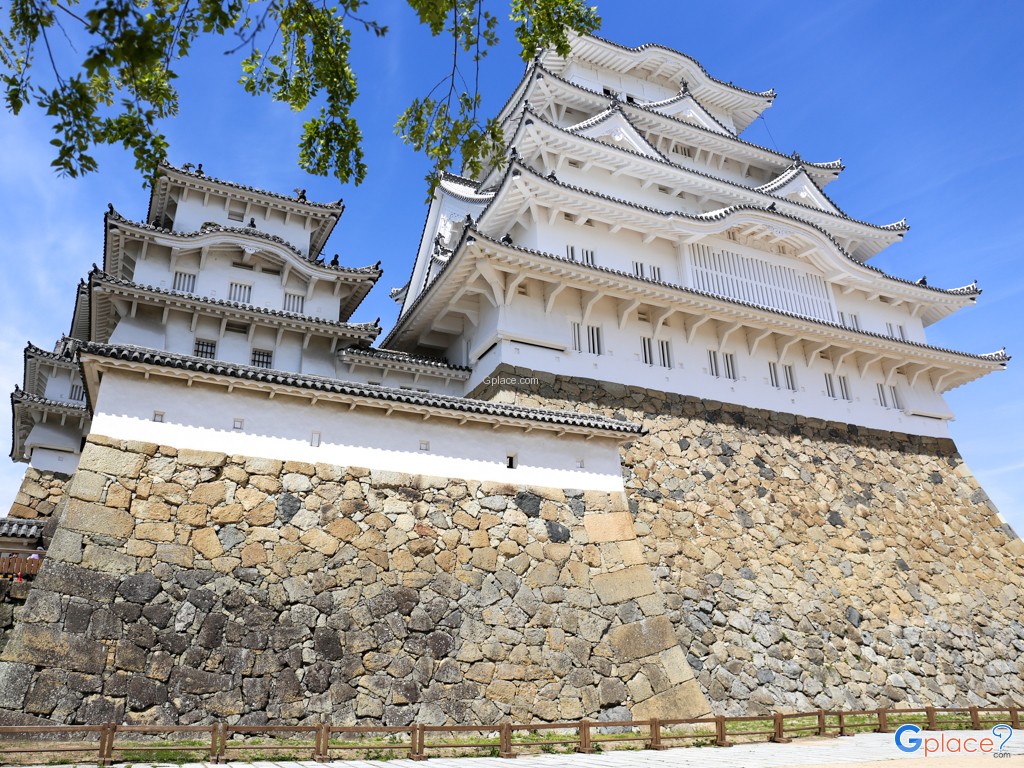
[6,31,1024,724]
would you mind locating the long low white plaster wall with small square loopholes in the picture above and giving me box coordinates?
[92,371,623,490]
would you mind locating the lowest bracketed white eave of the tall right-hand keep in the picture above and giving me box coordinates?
[384,230,1010,392]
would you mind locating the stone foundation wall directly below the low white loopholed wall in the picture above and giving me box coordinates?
[0,436,710,724]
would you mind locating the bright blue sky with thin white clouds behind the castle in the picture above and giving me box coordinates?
[0,0,1024,532]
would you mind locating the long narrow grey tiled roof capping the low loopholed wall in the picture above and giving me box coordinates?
[80,342,643,435]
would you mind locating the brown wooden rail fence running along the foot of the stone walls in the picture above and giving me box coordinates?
[0,706,1021,766]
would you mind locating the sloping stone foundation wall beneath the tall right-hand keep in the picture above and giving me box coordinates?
[476,369,1024,714]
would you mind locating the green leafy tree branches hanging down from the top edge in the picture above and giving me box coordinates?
[0,0,600,183]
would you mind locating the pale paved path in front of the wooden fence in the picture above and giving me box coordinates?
[18,731,1024,768]
